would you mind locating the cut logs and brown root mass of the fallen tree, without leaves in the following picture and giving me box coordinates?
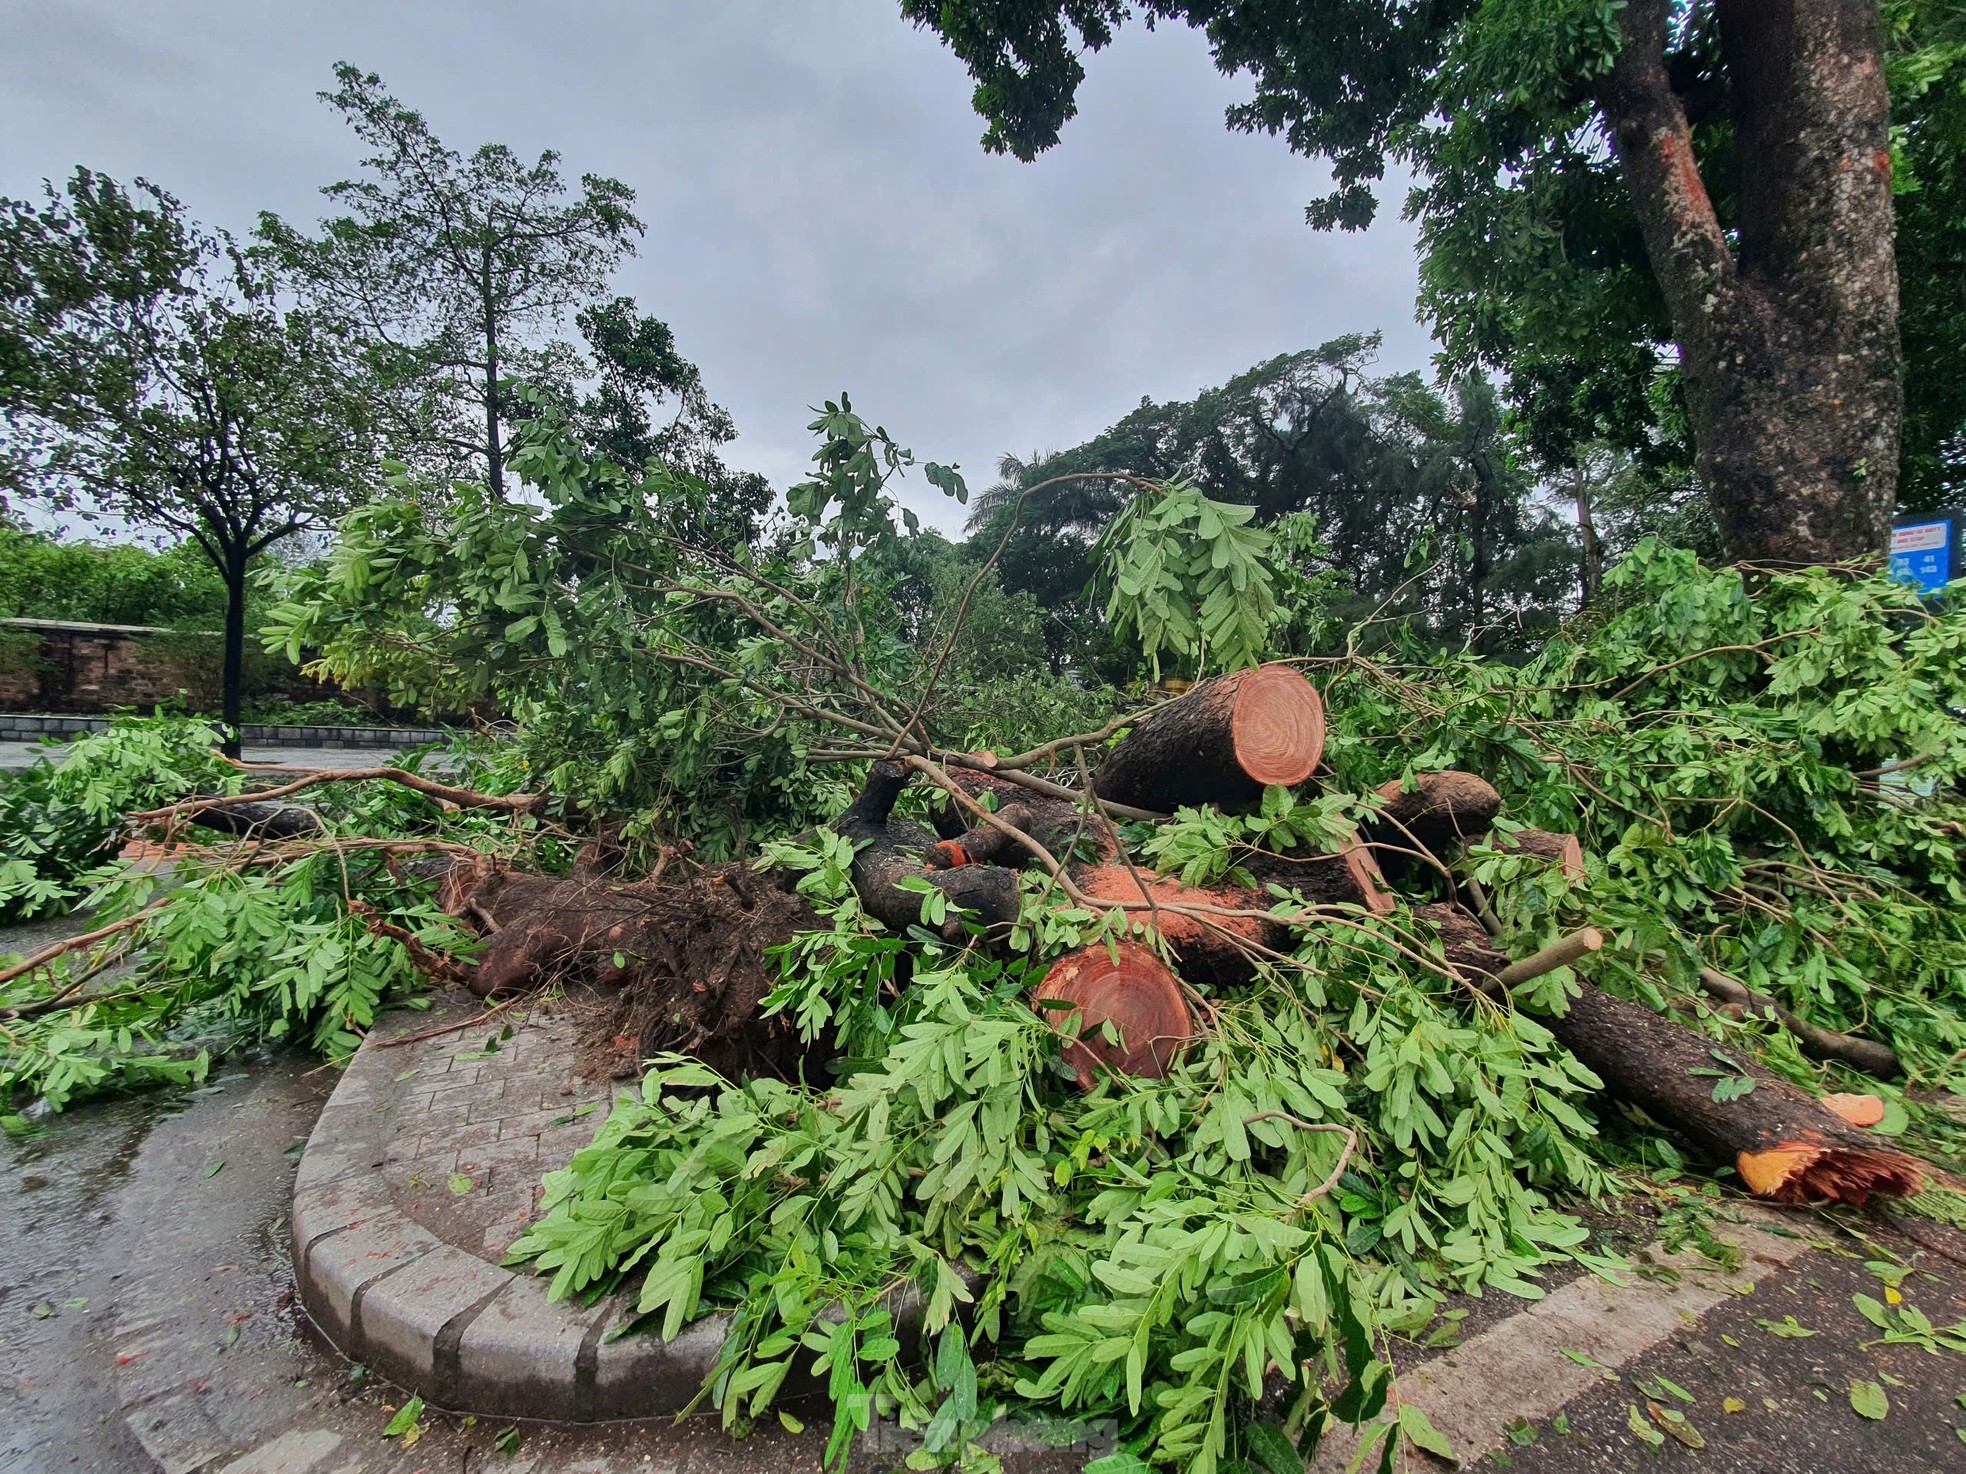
[379,664,1929,1205]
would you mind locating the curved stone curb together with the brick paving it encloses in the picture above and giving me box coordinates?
[291,998,729,1423]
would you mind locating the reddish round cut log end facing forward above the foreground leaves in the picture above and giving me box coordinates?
[1034,941,1195,1091]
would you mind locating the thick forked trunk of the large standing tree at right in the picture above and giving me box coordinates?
[1598,0,1903,564]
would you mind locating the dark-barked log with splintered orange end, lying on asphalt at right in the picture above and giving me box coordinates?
[1541,983,1929,1207]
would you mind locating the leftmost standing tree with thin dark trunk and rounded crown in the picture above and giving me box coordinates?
[0,169,379,753]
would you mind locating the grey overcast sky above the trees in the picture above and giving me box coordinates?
[0,0,1429,542]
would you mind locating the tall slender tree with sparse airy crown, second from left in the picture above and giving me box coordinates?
[260,61,643,497]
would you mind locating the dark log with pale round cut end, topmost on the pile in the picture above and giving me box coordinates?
[1093,664,1325,814]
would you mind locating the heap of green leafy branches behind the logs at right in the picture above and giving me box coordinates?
[1327,542,1966,1085]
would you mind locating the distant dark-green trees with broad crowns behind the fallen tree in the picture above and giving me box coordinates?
[971,334,1577,656]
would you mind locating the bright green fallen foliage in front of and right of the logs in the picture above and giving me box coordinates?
[495,542,1966,1470]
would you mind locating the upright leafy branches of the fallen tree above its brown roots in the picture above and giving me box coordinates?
[267,393,1077,857]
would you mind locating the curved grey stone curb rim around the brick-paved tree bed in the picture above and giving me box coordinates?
[291,1000,729,1423]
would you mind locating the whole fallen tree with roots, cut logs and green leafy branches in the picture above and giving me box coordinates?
[0,430,1966,1468]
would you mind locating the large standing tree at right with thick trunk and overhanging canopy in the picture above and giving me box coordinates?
[902,0,1903,562]
